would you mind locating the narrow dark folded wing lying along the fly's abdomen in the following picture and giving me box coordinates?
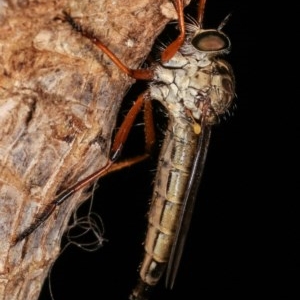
[166,126,211,289]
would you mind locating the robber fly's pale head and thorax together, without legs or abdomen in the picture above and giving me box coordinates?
[150,26,234,124]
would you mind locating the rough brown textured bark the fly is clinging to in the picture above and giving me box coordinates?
[0,0,176,300]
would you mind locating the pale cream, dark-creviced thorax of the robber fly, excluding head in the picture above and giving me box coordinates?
[150,57,234,124]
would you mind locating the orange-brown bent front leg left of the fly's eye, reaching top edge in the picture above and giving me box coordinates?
[161,0,185,62]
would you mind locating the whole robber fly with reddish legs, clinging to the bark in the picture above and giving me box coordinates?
[16,0,234,300]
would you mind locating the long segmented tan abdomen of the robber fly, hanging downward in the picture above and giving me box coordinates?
[132,120,197,299]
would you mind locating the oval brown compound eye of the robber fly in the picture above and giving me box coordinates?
[191,30,230,52]
